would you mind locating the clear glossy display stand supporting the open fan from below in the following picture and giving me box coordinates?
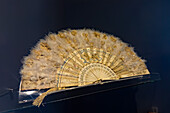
[0,73,160,113]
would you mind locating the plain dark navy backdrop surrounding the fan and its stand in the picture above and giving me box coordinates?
[0,0,170,113]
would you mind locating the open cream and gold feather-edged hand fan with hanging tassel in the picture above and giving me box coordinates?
[20,29,149,105]
